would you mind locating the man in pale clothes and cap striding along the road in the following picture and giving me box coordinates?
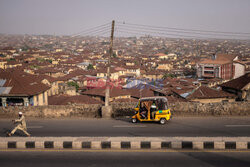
[8,112,30,137]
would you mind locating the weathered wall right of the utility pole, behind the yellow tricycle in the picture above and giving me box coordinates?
[113,102,250,117]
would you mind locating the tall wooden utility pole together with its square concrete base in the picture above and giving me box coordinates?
[102,20,115,118]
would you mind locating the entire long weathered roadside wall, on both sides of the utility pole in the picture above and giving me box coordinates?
[0,102,250,118]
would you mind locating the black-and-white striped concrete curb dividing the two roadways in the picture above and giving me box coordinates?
[0,137,250,150]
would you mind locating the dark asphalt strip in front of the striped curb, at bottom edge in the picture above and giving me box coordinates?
[0,151,250,167]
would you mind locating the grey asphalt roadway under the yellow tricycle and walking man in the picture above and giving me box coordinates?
[0,117,250,137]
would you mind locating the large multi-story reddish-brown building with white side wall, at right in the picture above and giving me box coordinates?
[196,54,245,80]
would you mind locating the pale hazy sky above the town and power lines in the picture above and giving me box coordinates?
[0,0,250,35]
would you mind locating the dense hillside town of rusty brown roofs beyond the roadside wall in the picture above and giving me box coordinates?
[0,34,250,106]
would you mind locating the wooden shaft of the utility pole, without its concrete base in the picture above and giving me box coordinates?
[105,20,115,106]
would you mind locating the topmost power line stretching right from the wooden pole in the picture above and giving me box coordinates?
[117,21,250,35]
